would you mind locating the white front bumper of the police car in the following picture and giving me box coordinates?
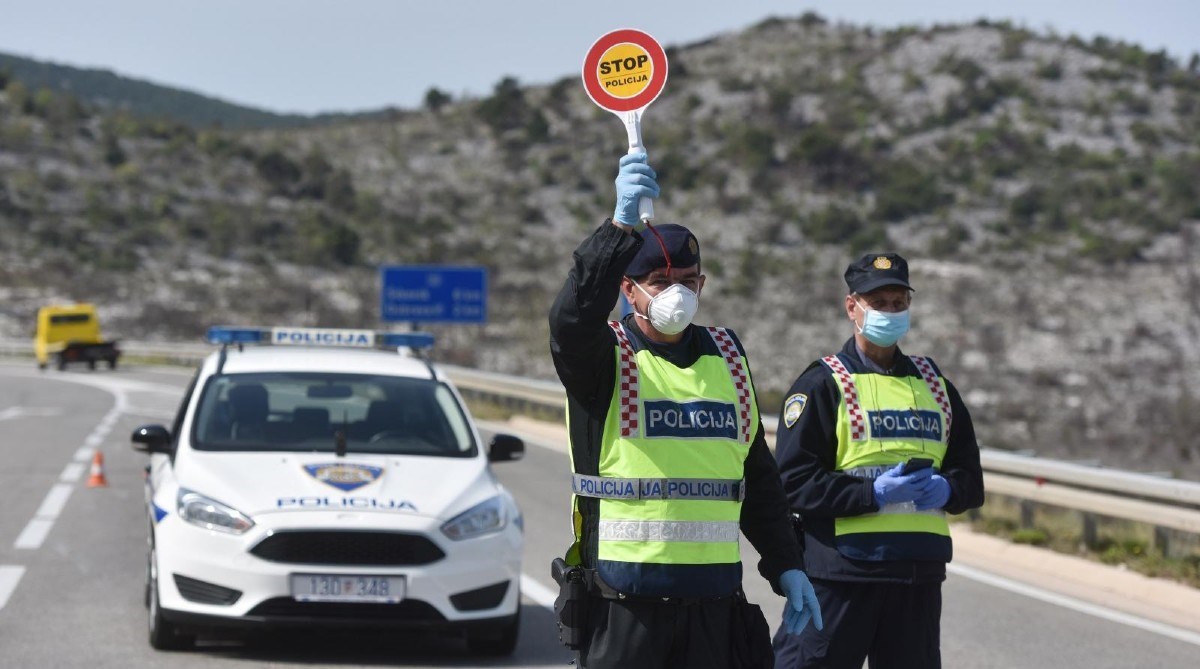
[155,511,522,629]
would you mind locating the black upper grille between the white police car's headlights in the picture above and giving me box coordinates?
[250,531,445,566]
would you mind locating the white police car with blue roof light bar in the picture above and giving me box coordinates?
[132,327,524,655]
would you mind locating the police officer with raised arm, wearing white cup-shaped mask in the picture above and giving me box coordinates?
[550,153,821,669]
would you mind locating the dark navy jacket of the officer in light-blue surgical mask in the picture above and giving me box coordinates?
[775,337,983,583]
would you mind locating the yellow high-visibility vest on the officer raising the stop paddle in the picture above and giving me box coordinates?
[572,321,758,597]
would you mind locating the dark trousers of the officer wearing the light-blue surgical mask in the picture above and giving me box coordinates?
[774,579,942,669]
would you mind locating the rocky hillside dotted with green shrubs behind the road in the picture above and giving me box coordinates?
[0,14,1200,480]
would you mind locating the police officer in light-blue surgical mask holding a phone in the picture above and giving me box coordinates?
[774,253,983,669]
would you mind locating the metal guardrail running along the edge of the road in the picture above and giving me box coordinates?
[0,339,1200,550]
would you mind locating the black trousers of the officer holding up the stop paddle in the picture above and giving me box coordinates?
[580,597,739,669]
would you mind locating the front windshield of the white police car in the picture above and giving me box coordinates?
[192,372,476,457]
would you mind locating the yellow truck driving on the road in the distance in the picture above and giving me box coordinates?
[34,302,121,369]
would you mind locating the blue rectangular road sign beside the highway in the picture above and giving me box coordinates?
[379,265,487,323]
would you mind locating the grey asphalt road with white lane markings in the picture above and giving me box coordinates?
[0,361,1200,669]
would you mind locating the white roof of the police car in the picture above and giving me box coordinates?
[203,346,445,380]
